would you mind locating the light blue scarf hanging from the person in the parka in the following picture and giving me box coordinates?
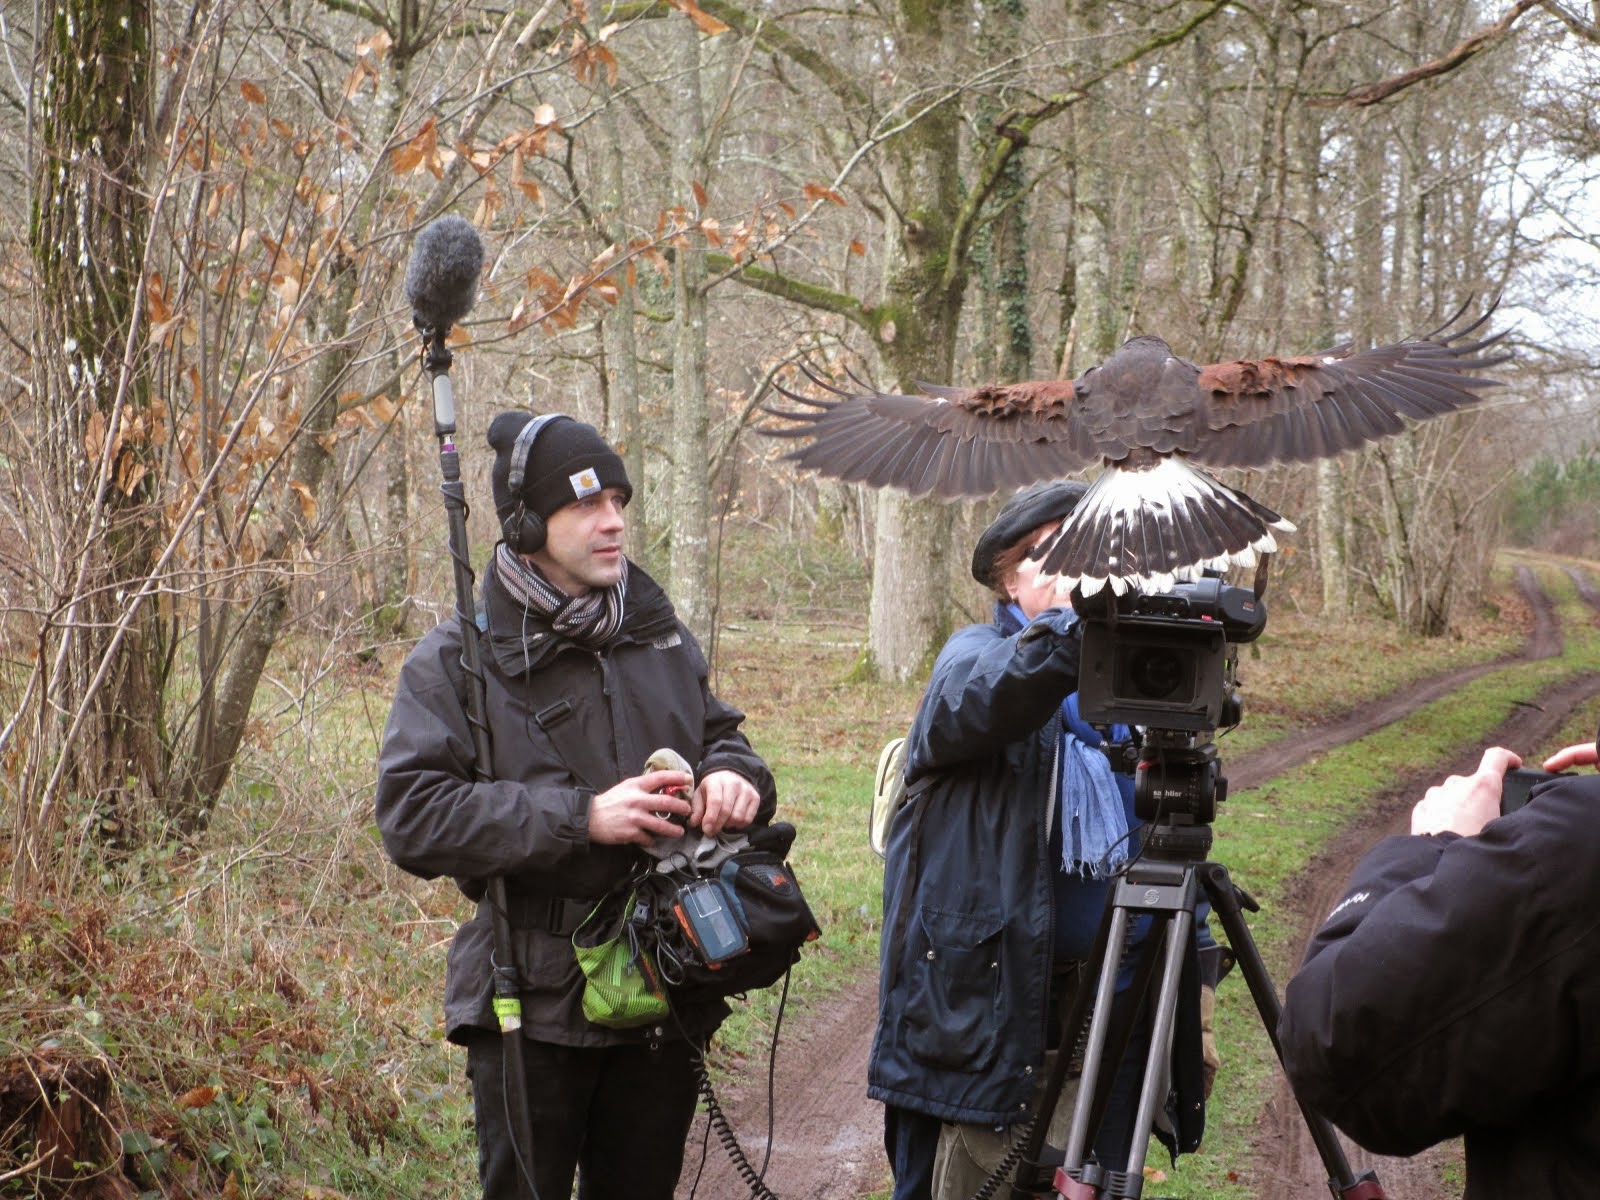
[1006,605,1131,878]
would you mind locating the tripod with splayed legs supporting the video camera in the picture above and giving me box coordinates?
[1013,780,1387,1200]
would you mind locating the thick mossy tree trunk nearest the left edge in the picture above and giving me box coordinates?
[16,0,168,886]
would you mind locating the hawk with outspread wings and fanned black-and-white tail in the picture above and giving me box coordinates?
[762,307,1510,595]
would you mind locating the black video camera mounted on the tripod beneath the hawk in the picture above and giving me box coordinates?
[1072,573,1267,824]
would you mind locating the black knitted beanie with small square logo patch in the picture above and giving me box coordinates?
[488,410,634,523]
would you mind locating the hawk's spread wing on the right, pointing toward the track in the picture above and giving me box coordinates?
[1187,306,1510,467]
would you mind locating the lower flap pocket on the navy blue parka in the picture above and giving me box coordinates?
[906,907,1005,1074]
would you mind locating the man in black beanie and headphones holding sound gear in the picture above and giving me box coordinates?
[376,411,776,1200]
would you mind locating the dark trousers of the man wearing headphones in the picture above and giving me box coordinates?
[467,1034,698,1200]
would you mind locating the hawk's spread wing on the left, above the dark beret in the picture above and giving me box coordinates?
[762,371,1101,499]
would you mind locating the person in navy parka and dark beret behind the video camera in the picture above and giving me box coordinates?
[867,483,1203,1200]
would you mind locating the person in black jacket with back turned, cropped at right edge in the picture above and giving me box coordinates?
[1278,729,1600,1200]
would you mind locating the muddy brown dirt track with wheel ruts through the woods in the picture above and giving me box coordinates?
[678,566,1600,1200]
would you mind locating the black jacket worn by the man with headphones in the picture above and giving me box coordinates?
[376,566,776,1045]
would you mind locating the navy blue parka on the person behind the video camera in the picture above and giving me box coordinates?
[867,605,1131,1125]
